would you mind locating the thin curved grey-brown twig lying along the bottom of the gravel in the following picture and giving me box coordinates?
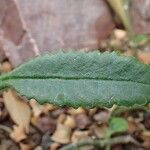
[60,135,139,150]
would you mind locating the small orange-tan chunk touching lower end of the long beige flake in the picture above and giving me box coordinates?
[10,126,27,142]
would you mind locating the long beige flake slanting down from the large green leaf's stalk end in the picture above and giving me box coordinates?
[3,90,31,132]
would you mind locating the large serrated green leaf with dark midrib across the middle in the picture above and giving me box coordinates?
[0,51,150,108]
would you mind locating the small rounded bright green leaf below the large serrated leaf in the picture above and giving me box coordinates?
[108,117,128,136]
